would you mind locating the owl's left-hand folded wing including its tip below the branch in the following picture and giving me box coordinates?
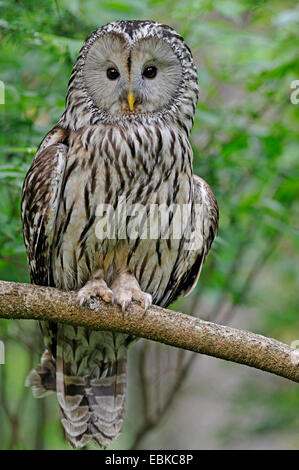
[21,128,68,397]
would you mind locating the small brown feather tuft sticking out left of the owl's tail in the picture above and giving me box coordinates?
[25,349,56,398]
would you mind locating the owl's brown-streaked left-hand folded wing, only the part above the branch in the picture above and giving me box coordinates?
[21,128,68,287]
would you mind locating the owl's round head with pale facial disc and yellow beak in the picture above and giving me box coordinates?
[63,21,198,126]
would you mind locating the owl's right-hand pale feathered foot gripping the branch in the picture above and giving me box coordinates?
[111,273,152,312]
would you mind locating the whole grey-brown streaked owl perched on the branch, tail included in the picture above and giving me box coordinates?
[22,21,218,448]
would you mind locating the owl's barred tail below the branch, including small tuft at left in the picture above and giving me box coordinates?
[26,325,127,447]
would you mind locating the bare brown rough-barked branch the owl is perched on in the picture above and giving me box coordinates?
[0,281,299,382]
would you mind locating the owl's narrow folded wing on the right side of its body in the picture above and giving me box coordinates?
[159,175,219,307]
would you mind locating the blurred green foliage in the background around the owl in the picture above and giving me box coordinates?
[0,0,299,449]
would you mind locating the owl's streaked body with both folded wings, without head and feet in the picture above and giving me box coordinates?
[22,122,218,306]
